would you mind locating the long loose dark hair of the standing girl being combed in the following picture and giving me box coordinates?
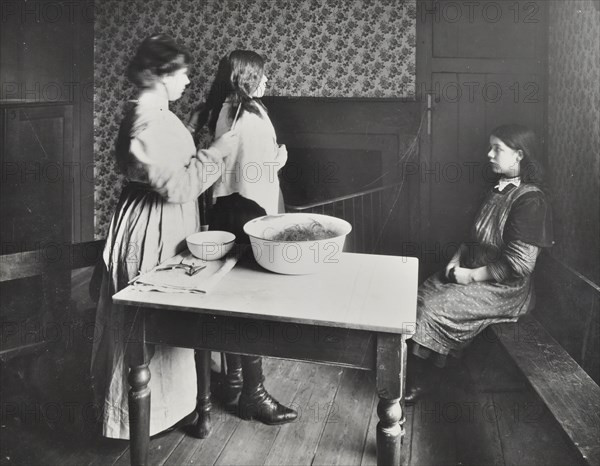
[196,50,266,139]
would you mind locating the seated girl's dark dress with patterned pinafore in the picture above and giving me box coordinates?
[413,184,552,366]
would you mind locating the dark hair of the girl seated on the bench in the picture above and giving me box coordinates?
[491,124,544,187]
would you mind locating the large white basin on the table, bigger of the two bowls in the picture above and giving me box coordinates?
[244,213,352,275]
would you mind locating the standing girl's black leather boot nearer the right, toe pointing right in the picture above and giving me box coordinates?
[238,356,298,425]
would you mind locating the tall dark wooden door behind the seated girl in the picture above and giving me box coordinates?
[417,0,547,276]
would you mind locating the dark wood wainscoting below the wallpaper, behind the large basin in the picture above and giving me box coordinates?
[263,97,421,255]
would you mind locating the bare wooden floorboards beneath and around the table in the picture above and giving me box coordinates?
[0,270,577,466]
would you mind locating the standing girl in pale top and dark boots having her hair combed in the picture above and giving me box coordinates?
[196,50,297,425]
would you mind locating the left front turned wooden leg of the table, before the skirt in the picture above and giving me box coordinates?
[125,308,153,466]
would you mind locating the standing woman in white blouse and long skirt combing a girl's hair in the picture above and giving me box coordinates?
[91,35,235,439]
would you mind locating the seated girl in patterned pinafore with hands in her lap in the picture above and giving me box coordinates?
[405,125,553,402]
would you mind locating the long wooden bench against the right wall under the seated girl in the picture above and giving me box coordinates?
[492,256,600,465]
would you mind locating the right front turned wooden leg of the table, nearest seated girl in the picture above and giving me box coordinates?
[377,333,406,466]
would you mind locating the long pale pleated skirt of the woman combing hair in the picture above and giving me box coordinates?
[91,183,200,439]
